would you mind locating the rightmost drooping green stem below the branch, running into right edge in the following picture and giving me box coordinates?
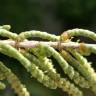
[67,50,96,93]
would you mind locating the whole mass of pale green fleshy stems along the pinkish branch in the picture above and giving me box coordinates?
[0,25,96,96]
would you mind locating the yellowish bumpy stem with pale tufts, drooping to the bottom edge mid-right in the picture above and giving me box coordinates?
[21,50,83,96]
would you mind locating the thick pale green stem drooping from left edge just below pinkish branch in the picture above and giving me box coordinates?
[0,43,57,89]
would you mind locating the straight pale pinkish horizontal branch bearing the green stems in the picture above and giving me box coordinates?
[0,40,96,49]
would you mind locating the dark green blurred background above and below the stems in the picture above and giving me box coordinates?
[0,0,96,96]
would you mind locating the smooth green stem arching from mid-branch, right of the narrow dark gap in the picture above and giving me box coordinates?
[30,44,88,87]
